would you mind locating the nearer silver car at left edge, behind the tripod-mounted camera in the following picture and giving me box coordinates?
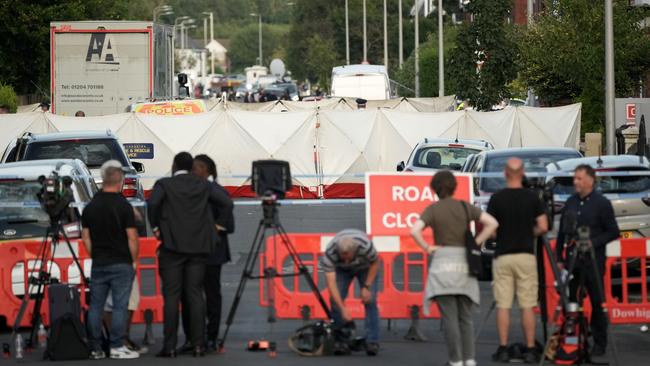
[0,159,98,242]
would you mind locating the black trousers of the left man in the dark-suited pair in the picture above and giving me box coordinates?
[158,248,207,351]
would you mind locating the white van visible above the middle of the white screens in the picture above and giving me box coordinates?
[331,65,391,100]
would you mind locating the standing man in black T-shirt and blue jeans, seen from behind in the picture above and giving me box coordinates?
[81,160,140,360]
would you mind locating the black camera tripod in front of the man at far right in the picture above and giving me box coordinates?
[539,227,618,366]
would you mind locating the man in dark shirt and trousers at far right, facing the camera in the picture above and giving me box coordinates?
[556,165,619,357]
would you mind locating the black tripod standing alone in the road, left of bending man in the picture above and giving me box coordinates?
[219,197,332,352]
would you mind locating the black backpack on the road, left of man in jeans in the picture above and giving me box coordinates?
[45,313,90,361]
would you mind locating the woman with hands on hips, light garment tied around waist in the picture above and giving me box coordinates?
[411,170,499,366]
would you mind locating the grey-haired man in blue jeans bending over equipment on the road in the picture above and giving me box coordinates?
[322,229,379,356]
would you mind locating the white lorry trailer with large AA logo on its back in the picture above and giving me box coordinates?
[50,21,174,116]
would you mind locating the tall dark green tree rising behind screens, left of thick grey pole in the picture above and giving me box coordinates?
[449,0,517,111]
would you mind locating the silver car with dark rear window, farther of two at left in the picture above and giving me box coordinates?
[2,130,147,235]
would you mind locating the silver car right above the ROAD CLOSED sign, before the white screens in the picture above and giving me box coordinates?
[397,138,494,172]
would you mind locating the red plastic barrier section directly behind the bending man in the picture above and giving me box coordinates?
[260,234,440,319]
